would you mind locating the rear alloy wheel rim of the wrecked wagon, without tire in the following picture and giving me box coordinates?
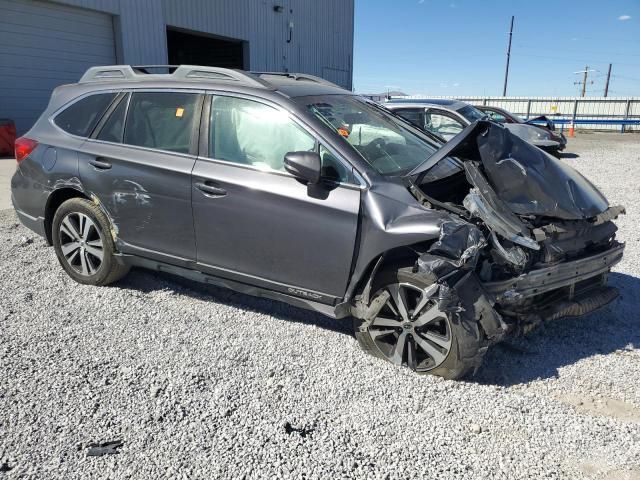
[60,212,104,276]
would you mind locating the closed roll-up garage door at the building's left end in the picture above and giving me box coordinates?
[0,0,116,135]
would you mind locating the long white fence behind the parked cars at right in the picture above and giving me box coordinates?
[390,96,640,132]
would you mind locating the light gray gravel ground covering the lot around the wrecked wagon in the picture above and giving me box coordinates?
[0,134,640,480]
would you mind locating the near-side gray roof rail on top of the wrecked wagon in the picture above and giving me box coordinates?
[79,65,273,89]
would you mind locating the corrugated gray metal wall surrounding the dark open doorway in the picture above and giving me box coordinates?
[46,0,354,89]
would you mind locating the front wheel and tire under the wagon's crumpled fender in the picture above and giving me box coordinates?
[354,268,488,380]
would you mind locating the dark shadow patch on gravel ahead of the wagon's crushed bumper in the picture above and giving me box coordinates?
[468,273,640,386]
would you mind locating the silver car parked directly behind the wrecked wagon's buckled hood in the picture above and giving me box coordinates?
[384,99,567,157]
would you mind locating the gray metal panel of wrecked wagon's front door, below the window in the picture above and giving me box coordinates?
[192,159,360,297]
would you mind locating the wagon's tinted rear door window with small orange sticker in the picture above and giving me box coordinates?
[124,92,199,153]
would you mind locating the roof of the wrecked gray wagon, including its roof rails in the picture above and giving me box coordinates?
[78,65,352,97]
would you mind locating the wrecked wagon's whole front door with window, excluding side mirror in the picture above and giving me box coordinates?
[193,95,361,303]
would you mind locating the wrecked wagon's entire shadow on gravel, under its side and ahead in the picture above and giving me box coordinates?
[115,269,640,386]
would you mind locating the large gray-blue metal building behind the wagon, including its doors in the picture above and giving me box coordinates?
[0,0,354,135]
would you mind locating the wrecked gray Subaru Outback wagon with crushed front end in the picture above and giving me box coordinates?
[11,65,624,378]
